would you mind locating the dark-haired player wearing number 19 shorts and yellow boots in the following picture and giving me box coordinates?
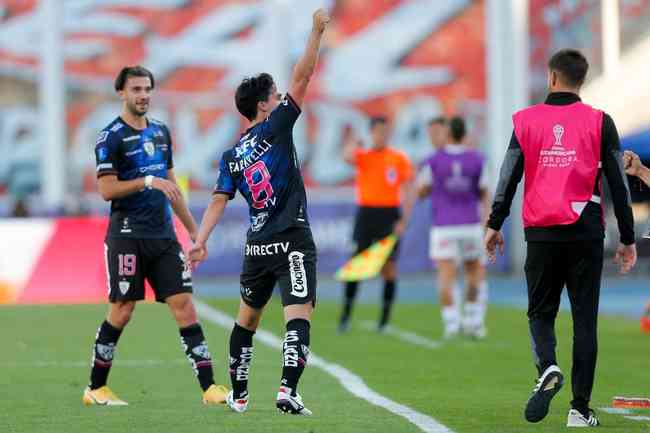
[83,66,228,405]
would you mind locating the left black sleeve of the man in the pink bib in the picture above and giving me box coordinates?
[487,131,524,231]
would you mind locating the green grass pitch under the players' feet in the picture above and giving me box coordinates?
[0,299,650,433]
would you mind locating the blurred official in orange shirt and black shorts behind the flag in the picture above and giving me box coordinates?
[339,117,415,332]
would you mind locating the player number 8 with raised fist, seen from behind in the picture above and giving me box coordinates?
[190,9,330,415]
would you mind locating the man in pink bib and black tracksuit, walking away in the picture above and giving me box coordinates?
[485,50,636,427]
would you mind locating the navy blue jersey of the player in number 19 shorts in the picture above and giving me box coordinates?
[95,117,176,239]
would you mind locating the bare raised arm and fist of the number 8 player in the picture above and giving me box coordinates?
[289,9,330,106]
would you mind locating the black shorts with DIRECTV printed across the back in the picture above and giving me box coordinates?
[240,224,316,309]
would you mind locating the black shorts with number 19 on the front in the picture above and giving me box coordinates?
[104,238,192,302]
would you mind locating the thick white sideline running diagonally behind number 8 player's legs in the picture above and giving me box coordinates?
[194,299,454,433]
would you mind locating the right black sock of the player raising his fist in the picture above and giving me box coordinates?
[282,319,310,396]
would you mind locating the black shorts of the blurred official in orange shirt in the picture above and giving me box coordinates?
[352,207,402,261]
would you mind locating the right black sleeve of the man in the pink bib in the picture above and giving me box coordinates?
[601,114,634,245]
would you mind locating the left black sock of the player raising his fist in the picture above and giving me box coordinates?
[230,323,255,399]
